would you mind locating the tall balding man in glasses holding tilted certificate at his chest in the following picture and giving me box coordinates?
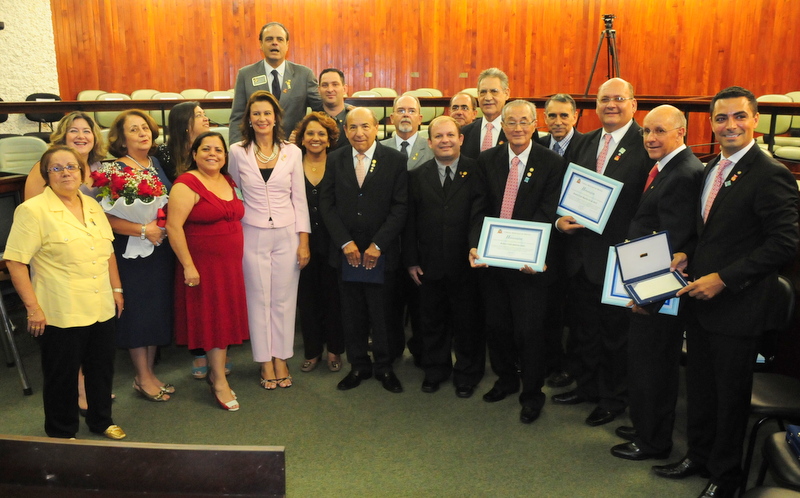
[553,78,654,426]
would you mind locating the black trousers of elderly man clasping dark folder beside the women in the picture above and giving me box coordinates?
[339,270,395,375]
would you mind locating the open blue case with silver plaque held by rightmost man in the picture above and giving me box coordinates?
[615,231,687,306]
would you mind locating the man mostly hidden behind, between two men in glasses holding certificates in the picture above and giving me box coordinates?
[537,93,583,387]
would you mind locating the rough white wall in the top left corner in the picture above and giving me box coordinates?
[0,0,58,133]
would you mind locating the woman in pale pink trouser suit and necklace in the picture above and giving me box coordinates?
[229,91,311,390]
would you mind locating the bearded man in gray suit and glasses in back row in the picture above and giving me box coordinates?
[381,95,433,171]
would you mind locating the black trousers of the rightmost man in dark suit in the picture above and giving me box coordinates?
[686,319,759,486]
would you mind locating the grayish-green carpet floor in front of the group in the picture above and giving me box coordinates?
[0,298,770,497]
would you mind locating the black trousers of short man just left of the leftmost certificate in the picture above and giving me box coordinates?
[419,270,486,386]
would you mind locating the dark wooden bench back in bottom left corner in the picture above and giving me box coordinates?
[0,435,286,497]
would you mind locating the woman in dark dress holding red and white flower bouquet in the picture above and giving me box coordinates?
[101,109,175,401]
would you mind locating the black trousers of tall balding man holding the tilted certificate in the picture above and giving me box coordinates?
[570,270,631,411]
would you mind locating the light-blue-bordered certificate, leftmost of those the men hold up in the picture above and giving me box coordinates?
[478,216,552,271]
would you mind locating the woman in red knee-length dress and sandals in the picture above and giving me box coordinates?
[167,132,248,411]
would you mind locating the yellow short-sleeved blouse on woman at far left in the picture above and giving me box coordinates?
[3,187,114,328]
